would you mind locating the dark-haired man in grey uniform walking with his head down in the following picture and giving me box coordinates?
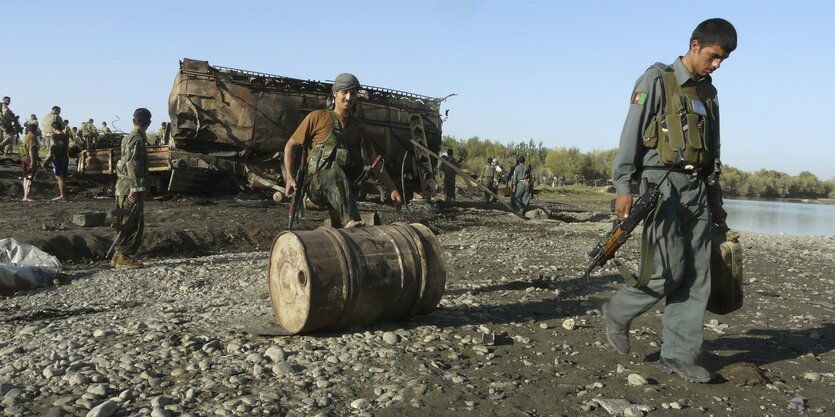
[603,19,737,382]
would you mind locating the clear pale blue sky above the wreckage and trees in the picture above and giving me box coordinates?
[6,0,835,180]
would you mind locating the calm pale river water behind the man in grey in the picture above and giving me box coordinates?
[725,199,835,236]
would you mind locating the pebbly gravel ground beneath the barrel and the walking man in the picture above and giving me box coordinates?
[0,195,835,416]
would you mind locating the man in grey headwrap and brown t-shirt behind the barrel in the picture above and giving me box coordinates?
[284,73,402,227]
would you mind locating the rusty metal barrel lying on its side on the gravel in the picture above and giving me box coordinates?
[267,223,446,334]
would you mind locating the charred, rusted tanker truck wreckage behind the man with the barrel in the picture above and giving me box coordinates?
[78,58,449,201]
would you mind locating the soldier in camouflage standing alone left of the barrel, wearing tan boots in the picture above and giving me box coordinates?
[111,108,151,269]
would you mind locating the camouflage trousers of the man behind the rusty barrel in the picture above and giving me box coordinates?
[307,167,361,227]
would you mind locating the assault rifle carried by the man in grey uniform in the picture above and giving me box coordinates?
[585,149,684,284]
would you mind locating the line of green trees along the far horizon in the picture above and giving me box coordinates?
[441,136,835,198]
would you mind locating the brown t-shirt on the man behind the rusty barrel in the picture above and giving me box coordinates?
[290,110,375,166]
